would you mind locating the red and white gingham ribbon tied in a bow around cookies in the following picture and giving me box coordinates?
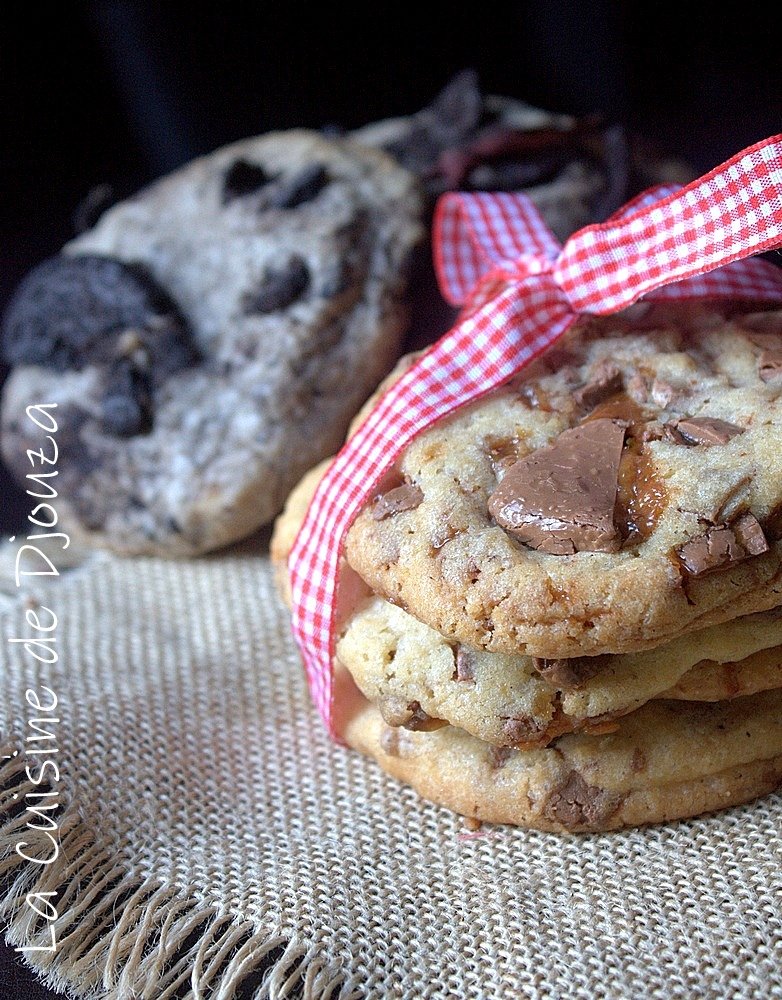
[289,135,782,739]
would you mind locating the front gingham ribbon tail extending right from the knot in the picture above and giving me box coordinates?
[554,135,782,314]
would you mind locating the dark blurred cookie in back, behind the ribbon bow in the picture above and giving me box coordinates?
[350,68,694,240]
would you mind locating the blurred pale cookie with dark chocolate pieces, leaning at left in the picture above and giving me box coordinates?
[2,130,424,556]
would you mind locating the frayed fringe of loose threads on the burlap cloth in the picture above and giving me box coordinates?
[0,742,361,1000]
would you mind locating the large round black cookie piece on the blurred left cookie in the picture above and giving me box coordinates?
[3,254,197,384]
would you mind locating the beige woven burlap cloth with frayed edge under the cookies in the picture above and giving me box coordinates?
[0,538,782,1000]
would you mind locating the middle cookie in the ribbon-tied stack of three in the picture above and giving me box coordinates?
[336,597,782,749]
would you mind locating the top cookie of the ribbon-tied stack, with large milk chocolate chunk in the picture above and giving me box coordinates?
[345,303,782,659]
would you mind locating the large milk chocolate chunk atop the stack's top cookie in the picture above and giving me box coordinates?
[489,419,625,555]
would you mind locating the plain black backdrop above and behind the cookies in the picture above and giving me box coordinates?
[0,0,782,1000]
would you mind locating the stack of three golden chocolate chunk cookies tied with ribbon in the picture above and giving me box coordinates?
[272,303,782,831]
